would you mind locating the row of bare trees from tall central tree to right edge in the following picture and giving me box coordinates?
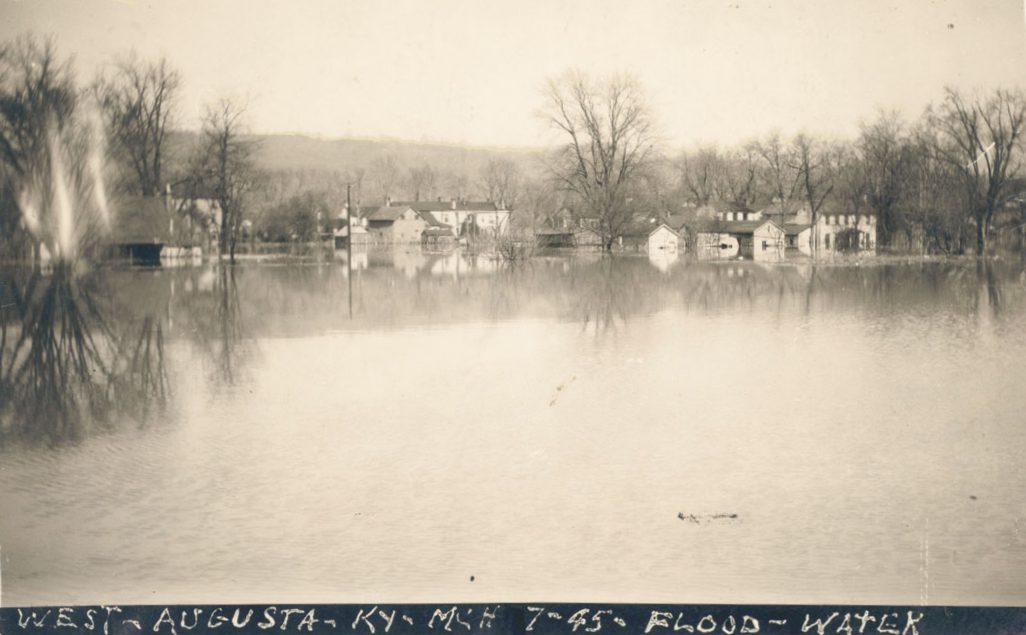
[543,72,1026,255]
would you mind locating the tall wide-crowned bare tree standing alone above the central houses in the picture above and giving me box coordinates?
[545,73,654,250]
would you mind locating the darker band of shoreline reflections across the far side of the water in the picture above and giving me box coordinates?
[0,249,1024,443]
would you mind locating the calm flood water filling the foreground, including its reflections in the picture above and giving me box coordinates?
[0,248,1026,605]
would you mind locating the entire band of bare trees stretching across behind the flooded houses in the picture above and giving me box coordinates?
[0,35,1026,257]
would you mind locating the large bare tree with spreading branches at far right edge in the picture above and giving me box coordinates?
[928,88,1026,256]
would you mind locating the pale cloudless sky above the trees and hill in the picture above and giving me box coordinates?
[0,0,1026,147]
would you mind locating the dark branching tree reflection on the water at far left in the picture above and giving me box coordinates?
[0,264,169,444]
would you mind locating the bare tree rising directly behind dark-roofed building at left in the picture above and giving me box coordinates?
[95,54,182,196]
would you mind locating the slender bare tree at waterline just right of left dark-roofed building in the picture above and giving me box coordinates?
[194,98,255,262]
